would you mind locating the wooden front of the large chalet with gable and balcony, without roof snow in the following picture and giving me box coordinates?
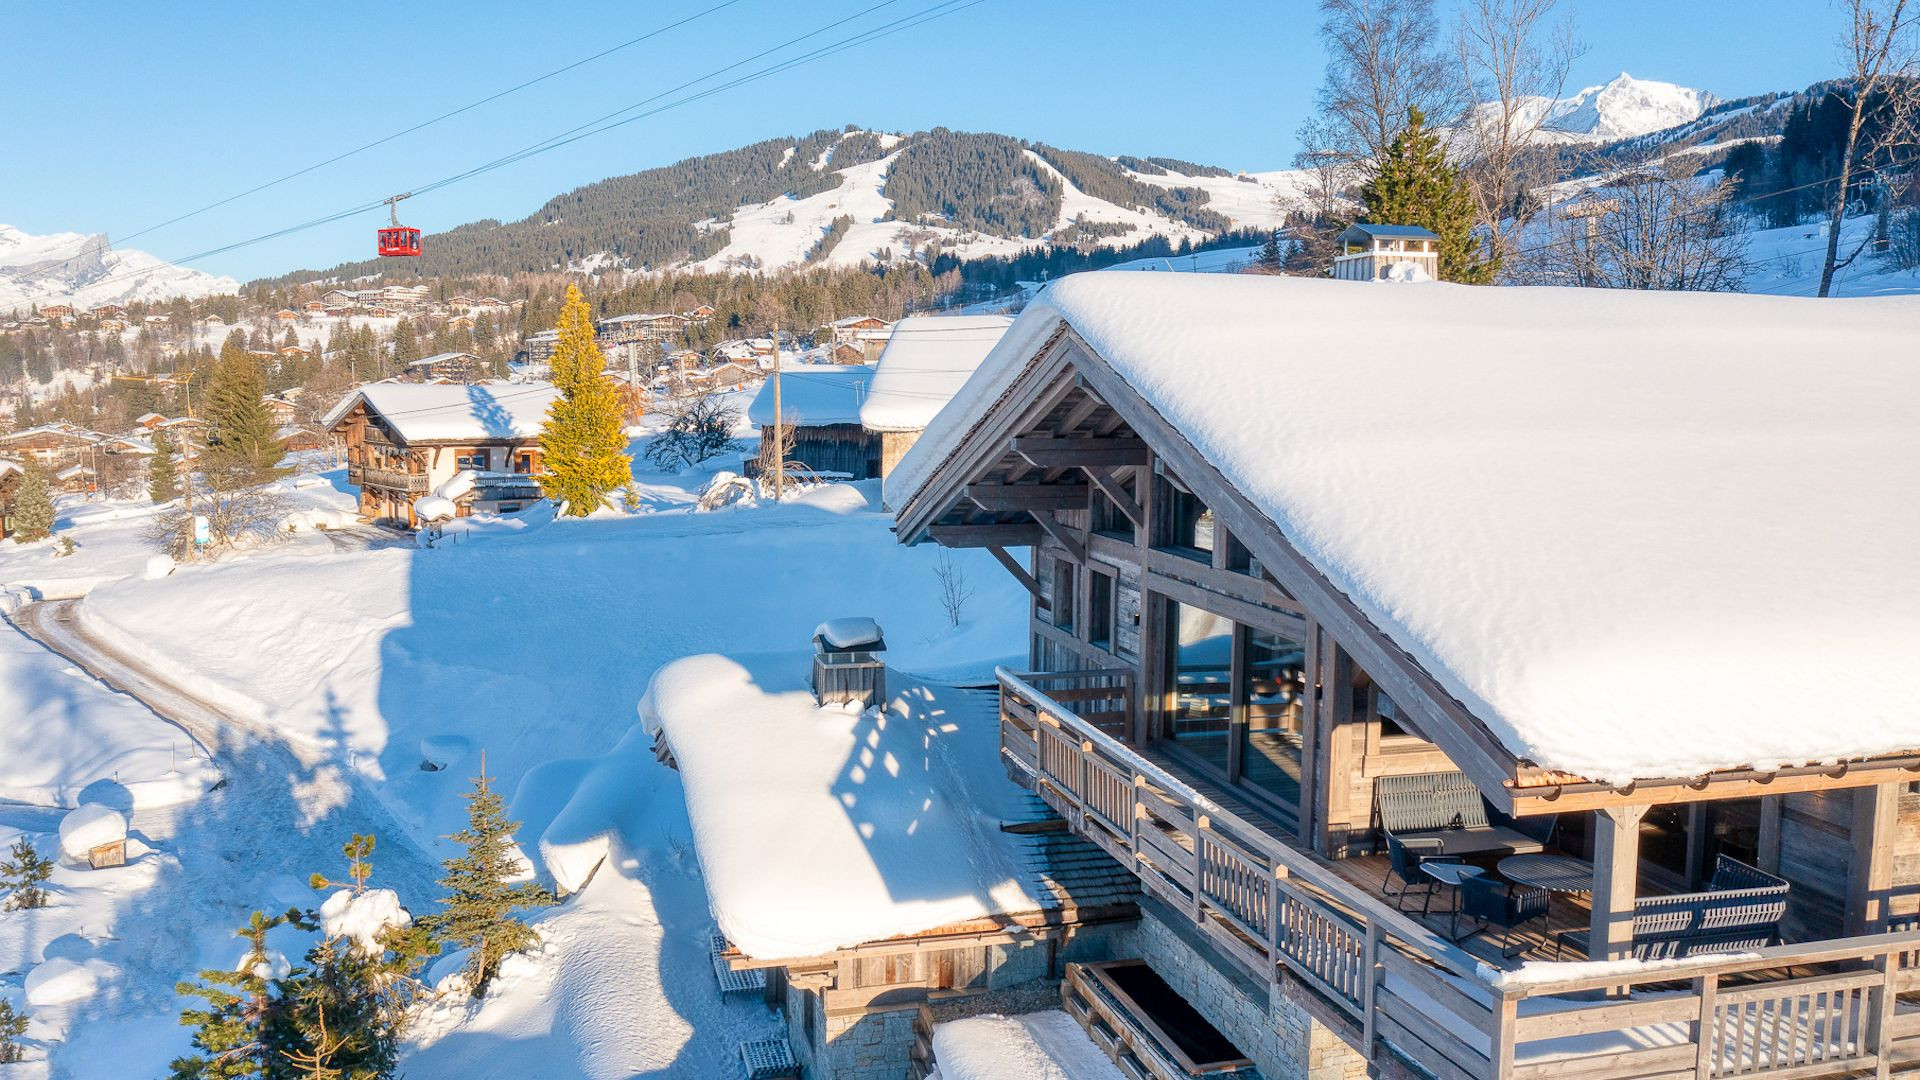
[895,327,1920,1078]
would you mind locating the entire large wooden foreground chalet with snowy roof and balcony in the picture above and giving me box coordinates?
[885,273,1920,1078]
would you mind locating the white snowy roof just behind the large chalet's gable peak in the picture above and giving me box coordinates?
[860,315,1014,430]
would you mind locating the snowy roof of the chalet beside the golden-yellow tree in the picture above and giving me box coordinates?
[321,382,561,442]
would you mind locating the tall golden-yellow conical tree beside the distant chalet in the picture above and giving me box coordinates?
[540,284,634,517]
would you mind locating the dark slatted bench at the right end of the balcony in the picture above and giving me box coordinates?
[1553,855,1791,961]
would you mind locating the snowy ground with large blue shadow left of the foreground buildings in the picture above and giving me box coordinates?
[0,424,1025,1080]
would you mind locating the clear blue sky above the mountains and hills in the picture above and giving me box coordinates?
[0,0,1839,279]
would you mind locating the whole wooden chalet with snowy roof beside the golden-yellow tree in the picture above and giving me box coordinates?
[321,382,559,528]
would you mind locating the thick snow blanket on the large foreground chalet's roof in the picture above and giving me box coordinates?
[887,273,1920,782]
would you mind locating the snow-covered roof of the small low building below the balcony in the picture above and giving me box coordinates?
[639,651,1041,961]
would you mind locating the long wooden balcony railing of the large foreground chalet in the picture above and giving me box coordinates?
[998,671,1920,1080]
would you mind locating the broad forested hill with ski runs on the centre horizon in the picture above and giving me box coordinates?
[261,127,1235,284]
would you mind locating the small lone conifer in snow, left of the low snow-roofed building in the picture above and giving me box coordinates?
[420,759,555,997]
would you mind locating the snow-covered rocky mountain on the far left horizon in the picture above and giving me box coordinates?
[0,225,240,311]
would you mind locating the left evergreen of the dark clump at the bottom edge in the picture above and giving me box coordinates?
[169,911,313,1080]
